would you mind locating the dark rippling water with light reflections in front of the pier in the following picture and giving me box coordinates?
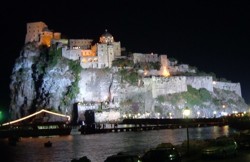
[0,126,234,162]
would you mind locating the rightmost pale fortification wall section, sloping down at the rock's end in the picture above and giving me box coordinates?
[213,81,241,97]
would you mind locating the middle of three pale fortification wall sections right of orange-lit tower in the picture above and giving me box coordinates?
[186,76,213,92]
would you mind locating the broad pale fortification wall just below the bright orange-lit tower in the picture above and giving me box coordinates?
[149,76,187,98]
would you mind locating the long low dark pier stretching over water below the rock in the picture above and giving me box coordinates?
[79,118,227,134]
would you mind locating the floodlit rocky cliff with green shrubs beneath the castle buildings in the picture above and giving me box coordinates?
[10,44,247,122]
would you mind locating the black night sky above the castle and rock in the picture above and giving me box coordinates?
[0,0,250,104]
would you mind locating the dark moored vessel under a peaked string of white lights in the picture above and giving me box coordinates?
[0,109,72,138]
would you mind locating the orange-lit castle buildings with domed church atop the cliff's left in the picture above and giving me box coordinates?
[25,22,121,68]
